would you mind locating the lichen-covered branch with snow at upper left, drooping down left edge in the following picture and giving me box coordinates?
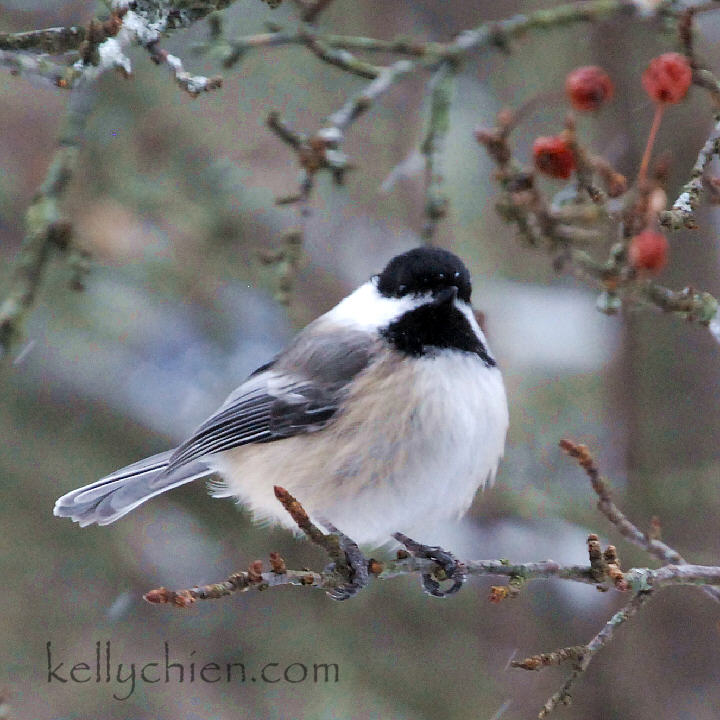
[0,0,245,354]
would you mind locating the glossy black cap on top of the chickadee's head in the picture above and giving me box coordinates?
[377,248,472,302]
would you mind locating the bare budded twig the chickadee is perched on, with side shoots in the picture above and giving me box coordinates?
[136,440,720,718]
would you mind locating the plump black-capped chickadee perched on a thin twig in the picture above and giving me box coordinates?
[54,248,508,547]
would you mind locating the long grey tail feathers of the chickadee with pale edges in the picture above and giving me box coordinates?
[53,451,212,527]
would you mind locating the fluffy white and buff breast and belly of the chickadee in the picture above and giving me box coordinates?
[208,352,508,546]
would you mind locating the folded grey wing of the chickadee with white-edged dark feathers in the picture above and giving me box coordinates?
[166,318,377,473]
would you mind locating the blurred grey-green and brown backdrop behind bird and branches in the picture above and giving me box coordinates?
[0,0,720,720]
